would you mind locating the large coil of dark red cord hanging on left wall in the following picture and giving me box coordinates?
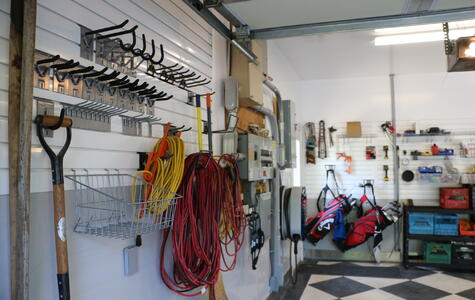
[160,153,223,297]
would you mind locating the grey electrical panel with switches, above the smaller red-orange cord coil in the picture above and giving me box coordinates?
[238,134,274,181]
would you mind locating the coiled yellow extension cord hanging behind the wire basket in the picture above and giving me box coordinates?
[132,136,185,217]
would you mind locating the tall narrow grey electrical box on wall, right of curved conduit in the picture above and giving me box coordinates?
[282,100,297,168]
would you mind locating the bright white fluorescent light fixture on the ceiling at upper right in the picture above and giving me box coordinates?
[374,20,475,46]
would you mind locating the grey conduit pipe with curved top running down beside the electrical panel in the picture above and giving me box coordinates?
[252,106,284,292]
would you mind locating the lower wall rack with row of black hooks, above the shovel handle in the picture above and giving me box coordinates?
[34,51,191,136]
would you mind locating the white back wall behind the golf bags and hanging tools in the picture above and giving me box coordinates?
[269,31,475,260]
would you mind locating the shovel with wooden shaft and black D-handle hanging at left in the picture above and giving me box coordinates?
[35,109,73,300]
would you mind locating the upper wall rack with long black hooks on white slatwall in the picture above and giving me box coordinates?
[81,20,211,93]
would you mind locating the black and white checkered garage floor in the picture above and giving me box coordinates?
[279,262,475,300]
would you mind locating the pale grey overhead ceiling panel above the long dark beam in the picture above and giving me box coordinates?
[226,0,475,30]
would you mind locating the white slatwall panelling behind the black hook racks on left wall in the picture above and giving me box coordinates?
[0,0,220,194]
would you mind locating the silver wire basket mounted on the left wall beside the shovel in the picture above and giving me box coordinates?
[65,174,183,239]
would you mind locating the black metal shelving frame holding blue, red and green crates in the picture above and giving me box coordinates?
[403,206,475,270]
